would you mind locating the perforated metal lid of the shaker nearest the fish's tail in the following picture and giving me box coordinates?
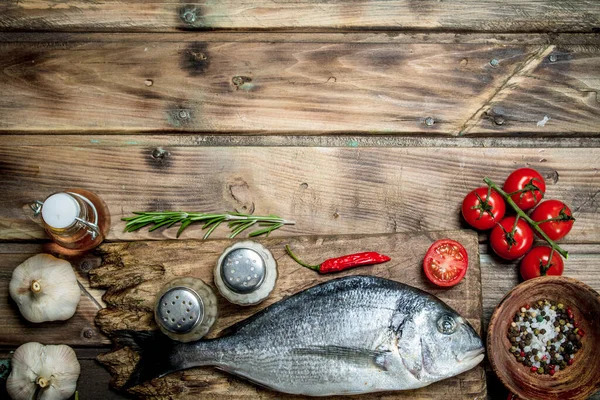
[156,286,204,333]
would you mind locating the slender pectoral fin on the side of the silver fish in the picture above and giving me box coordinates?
[293,345,392,371]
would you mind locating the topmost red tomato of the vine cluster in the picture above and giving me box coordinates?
[503,168,546,210]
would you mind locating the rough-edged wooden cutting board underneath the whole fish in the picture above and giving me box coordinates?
[90,231,486,400]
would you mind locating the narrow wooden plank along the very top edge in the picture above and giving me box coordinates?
[0,0,600,32]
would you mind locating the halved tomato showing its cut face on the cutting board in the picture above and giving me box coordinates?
[423,239,469,287]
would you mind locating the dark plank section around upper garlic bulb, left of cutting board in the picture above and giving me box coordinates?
[0,245,109,346]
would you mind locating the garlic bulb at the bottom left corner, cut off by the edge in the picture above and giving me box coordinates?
[6,342,80,400]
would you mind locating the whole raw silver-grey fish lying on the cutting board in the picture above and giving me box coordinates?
[115,276,484,396]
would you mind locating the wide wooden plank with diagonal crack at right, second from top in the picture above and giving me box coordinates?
[0,33,600,136]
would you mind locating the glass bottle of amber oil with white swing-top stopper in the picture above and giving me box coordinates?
[30,189,110,251]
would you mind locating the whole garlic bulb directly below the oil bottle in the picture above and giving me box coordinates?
[9,254,81,322]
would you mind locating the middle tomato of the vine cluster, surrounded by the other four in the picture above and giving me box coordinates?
[490,217,533,260]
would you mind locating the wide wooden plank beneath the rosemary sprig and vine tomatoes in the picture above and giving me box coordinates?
[0,145,600,243]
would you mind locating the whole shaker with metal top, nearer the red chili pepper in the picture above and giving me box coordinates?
[215,241,277,305]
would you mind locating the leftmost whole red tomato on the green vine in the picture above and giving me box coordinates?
[462,186,506,230]
